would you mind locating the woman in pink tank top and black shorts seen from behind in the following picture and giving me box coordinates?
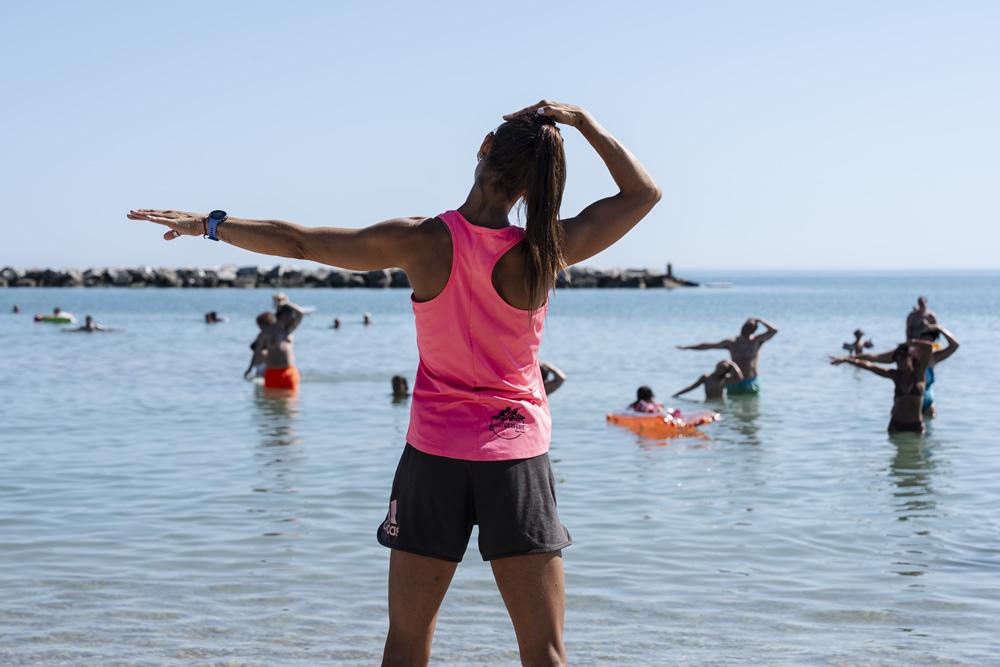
[128,100,660,665]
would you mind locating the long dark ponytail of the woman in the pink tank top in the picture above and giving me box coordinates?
[524,118,566,310]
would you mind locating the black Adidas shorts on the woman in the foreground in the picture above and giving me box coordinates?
[378,444,572,563]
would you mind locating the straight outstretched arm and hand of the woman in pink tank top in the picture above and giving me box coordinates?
[127,209,427,271]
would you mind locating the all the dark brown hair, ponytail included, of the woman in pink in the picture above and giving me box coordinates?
[484,114,566,303]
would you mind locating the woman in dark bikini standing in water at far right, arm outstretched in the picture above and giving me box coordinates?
[830,340,933,433]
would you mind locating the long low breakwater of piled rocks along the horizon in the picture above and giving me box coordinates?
[0,265,696,289]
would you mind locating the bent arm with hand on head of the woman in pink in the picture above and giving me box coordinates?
[504,100,662,264]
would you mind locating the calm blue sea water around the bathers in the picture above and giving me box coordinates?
[0,273,1000,667]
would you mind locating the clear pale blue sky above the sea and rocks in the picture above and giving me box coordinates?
[0,0,1000,272]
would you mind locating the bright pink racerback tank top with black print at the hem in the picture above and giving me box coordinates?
[406,211,552,461]
